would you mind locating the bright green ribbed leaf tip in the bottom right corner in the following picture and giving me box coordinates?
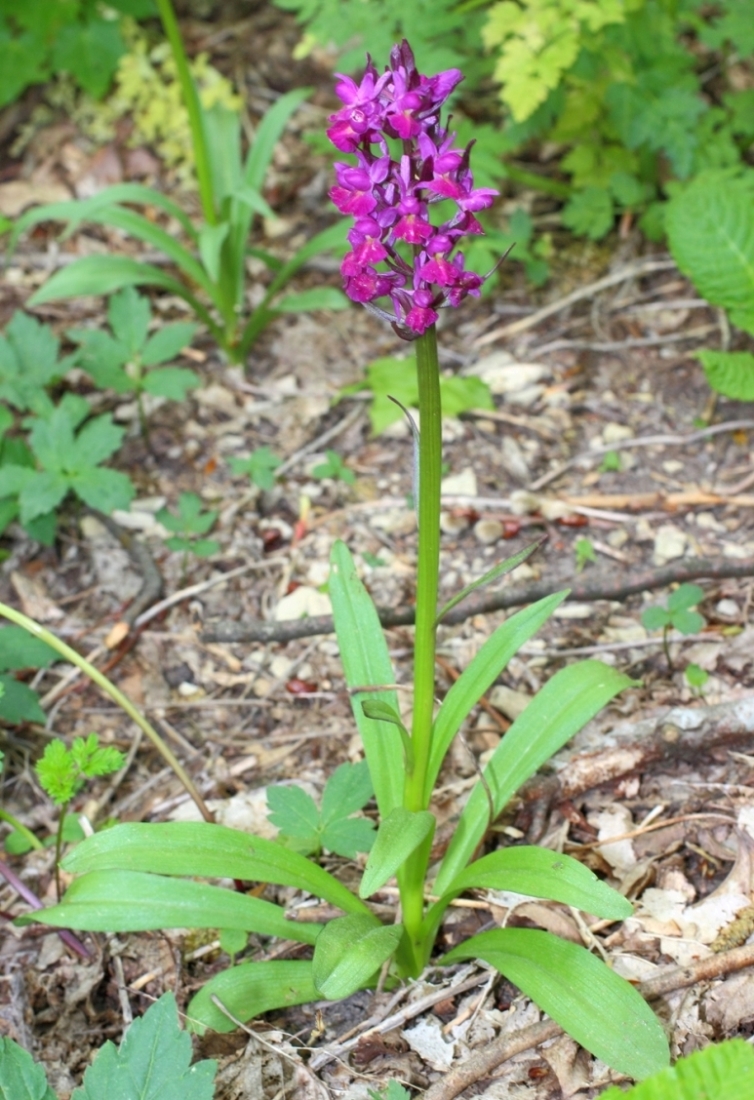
[600,1038,754,1100]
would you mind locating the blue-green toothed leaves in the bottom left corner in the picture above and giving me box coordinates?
[0,993,217,1100]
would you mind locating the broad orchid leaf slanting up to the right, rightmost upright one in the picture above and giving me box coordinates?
[435,661,634,894]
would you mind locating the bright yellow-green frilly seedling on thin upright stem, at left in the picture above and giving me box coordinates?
[36,730,125,899]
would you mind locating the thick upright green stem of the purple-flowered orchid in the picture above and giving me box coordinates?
[400,326,442,975]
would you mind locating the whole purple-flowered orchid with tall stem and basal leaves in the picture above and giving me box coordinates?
[13,41,668,1079]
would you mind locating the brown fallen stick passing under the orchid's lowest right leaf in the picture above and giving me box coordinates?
[424,944,754,1100]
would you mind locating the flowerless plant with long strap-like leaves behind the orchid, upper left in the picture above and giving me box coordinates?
[10,0,348,363]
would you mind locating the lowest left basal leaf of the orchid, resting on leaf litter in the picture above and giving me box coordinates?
[189,960,319,1034]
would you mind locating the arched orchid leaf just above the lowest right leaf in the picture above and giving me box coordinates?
[438,847,634,921]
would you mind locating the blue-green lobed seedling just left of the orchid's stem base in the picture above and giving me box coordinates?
[267,760,375,859]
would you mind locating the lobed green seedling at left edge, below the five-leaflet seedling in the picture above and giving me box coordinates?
[2,394,134,545]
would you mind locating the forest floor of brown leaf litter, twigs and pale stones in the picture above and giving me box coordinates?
[0,9,754,1100]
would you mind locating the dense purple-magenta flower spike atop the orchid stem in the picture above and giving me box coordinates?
[327,39,498,340]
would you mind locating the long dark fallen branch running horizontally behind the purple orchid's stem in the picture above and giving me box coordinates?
[201,558,754,642]
